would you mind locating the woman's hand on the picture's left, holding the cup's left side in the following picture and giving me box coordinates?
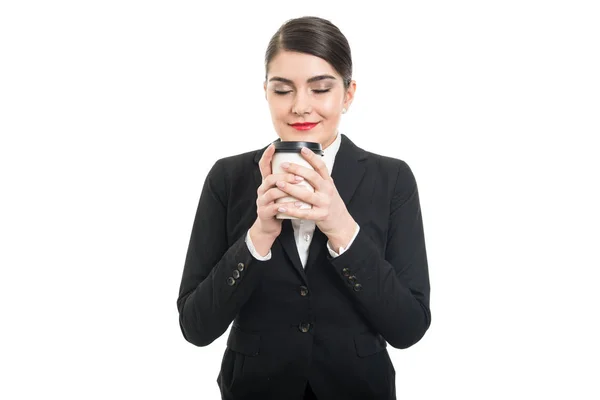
[250,144,304,244]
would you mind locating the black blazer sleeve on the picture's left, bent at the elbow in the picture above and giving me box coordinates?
[177,160,270,346]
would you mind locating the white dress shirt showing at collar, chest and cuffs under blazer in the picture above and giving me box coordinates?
[246,132,360,267]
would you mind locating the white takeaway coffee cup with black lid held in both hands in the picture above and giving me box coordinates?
[271,141,323,219]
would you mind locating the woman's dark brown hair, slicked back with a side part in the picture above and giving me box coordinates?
[265,16,352,89]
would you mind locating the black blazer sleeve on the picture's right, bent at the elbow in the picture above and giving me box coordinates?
[328,161,431,348]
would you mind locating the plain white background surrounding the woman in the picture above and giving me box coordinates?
[0,0,600,400]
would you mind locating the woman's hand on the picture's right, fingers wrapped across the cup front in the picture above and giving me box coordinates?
[277,148,356,246]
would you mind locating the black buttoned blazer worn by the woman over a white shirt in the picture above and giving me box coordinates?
[177,134,431,400]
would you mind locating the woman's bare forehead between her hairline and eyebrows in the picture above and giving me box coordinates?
[268,51,341,83]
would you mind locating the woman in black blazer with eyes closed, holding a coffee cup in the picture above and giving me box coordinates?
[177,17,431,400]
